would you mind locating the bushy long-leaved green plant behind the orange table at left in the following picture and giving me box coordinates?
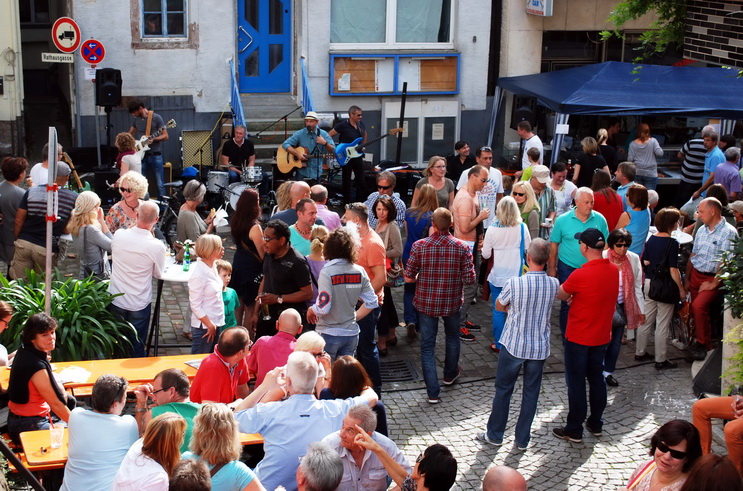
[0,270,136,361]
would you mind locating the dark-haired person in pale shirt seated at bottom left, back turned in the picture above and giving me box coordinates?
[60,373,139,491]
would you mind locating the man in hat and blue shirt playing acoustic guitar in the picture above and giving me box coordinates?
[281,111,335,183]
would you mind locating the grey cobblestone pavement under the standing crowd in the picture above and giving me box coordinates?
[56,234,725,490]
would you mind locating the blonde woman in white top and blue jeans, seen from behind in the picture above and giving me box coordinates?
[482,196,531,353]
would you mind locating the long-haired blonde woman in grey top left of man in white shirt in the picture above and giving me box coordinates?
[67,191,112,279]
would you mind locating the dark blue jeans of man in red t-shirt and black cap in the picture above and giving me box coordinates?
[564,340,608,437]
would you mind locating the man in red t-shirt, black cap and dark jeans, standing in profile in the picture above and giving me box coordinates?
[552,228,619,443]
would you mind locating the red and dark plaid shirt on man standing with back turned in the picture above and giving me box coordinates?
[405,232,475,317]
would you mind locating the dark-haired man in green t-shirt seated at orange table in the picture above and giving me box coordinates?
[134,368,201,452]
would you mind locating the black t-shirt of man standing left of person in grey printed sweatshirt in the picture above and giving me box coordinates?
[263,246,312,319]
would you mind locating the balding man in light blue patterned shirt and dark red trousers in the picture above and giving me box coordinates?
[684,198,738,360]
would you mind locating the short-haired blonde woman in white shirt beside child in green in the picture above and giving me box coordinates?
[188,234,224,354]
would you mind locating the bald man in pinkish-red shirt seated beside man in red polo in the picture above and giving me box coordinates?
[248,309,302,387]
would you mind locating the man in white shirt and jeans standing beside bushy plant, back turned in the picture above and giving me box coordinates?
[108,201,166,357]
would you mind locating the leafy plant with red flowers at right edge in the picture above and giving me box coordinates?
[720,237,743,392]
